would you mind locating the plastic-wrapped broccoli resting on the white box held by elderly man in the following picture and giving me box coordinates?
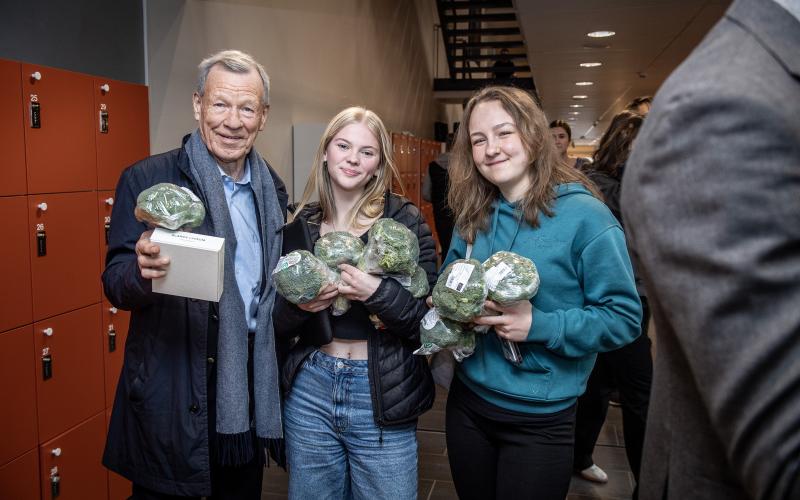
[133,182,206,230]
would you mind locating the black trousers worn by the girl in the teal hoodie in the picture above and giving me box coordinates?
[446,377,575,500]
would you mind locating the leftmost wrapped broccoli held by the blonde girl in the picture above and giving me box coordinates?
[272,250,338,304]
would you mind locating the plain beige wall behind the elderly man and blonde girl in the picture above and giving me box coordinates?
[145,0,444,198]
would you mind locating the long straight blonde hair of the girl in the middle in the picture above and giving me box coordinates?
[294,106,399,228]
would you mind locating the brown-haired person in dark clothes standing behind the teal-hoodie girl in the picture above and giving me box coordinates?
[574,111,653,498]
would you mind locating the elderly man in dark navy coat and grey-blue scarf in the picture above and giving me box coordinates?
[103,50,287,499]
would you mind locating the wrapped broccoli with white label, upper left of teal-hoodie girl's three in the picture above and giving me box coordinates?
[433,259,487,323]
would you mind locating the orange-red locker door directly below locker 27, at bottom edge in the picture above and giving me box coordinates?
[39,412,108,500]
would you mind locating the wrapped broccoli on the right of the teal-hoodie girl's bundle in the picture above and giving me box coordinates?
[483,251,539,305]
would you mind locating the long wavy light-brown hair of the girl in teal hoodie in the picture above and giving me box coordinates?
[447,86,600,242]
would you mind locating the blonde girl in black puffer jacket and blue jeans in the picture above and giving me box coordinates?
[274,107,436,499]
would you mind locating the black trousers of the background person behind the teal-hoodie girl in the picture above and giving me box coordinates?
[574,297,653,483]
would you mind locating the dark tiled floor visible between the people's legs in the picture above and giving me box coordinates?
[262,387,633,500]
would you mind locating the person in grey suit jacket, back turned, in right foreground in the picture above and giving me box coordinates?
[622,0,800,500]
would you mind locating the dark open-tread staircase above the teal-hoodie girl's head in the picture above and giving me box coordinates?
[433,0,538,101]
